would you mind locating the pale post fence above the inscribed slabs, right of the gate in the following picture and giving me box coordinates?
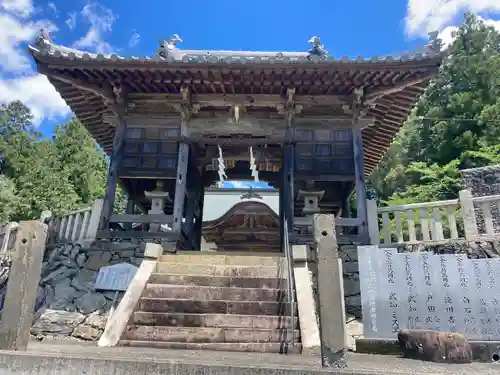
[367,190,500,246]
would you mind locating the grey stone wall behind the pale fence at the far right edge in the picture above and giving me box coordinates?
[461,165,500,233]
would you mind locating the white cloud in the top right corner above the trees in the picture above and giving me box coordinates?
[406,0,500,36]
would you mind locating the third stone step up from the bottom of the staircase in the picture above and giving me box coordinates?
[130,312,299,329]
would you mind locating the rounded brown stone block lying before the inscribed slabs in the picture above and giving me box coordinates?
[398,330,472,363]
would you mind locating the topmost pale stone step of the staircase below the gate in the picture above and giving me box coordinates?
[160,251,286,268]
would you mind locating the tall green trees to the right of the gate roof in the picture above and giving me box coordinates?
[369,13,500,204]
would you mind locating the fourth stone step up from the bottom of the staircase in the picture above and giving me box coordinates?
[136,298,297,316]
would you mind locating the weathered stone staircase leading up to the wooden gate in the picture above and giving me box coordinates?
[119,252,301,353]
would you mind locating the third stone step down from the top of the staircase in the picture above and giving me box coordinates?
[149,273,287,289]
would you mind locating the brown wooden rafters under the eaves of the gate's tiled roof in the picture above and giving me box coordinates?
[39,58,441,173]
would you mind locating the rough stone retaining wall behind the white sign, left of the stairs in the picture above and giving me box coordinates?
[31,244,143,341]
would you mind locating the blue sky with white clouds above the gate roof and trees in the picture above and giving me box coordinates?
[0,0,500,188]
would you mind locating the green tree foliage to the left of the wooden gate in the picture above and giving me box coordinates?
[0,102,123,223]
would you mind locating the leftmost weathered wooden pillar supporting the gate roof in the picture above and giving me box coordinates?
[99,97,127,234]
